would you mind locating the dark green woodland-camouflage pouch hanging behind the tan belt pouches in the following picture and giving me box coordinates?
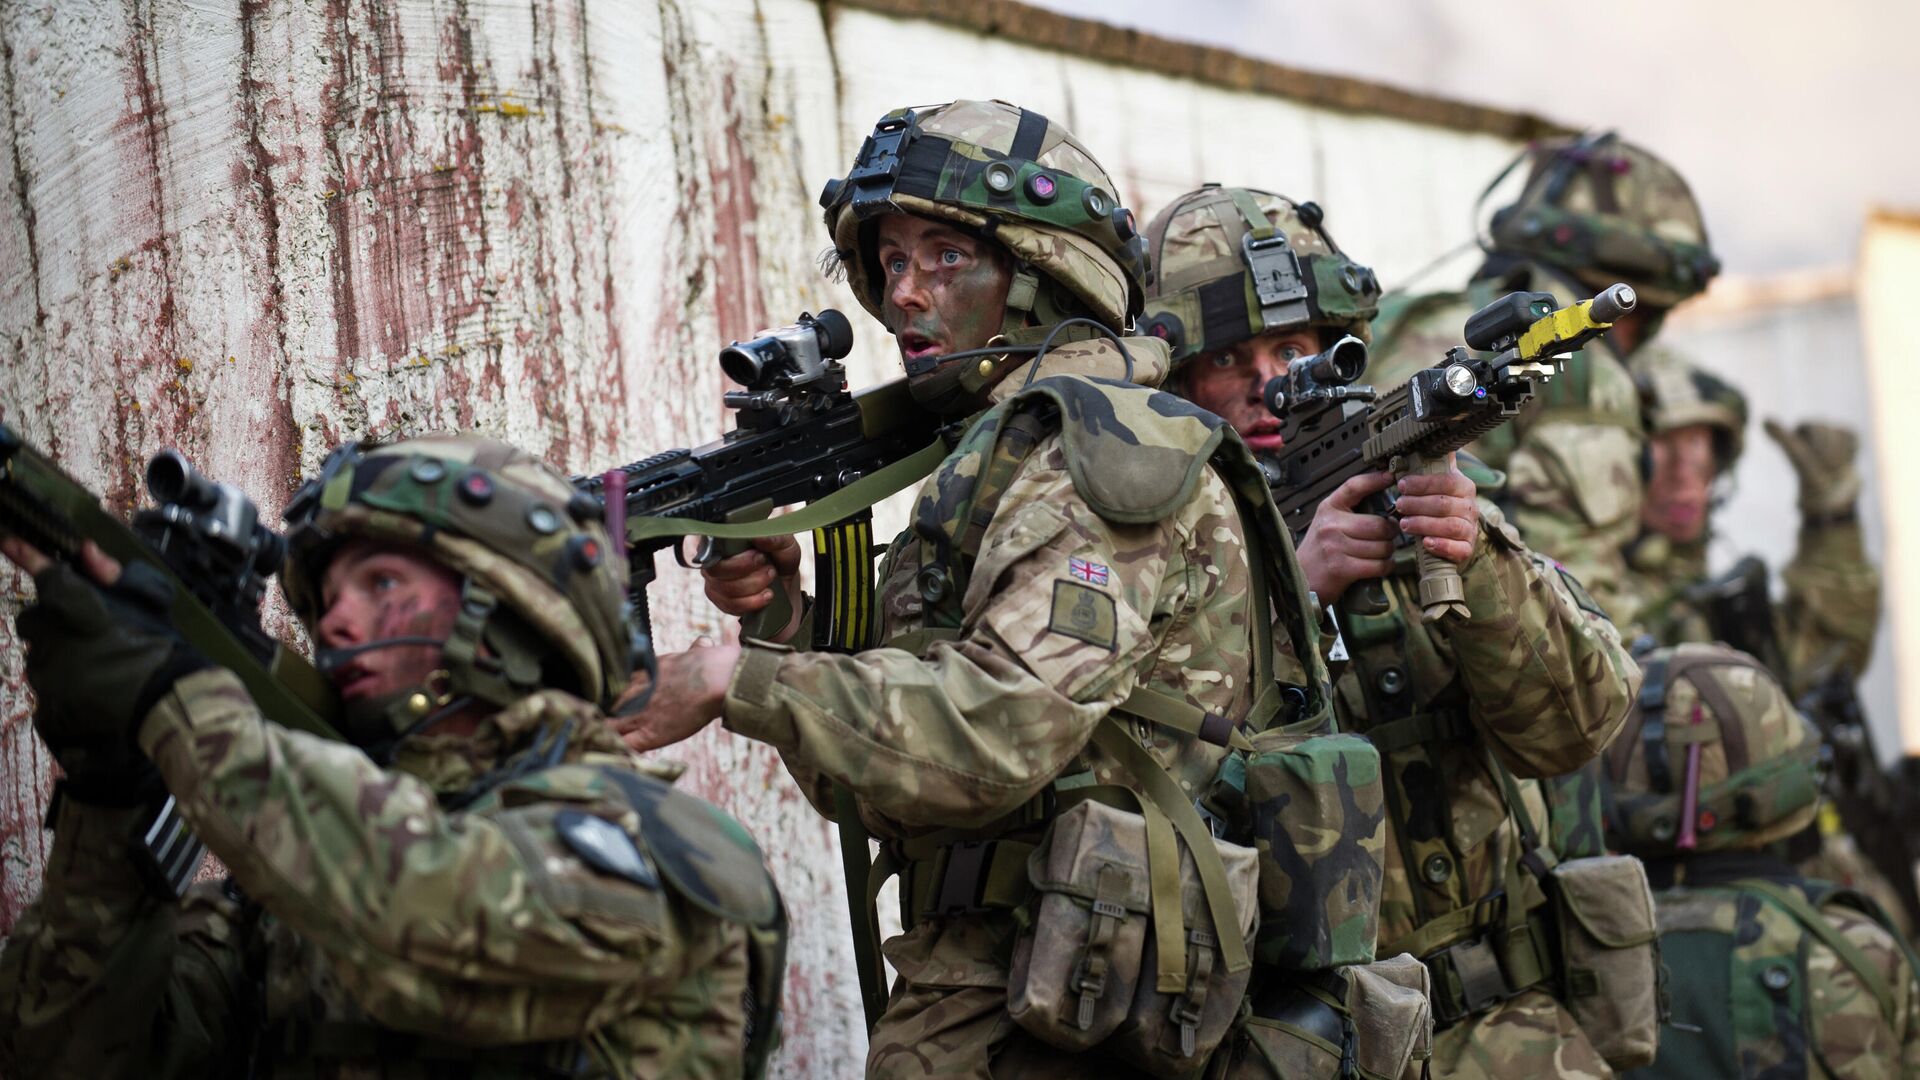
[1223,728,1386,970]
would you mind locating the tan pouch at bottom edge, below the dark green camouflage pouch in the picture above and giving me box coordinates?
[1210,953,1434,1080]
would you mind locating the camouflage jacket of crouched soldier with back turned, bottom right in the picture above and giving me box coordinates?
[1626,869,1920,1080]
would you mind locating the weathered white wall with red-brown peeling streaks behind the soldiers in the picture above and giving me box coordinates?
[0,0,1758,1076]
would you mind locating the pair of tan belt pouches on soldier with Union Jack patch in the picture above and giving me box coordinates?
[1008,792,1258,1076]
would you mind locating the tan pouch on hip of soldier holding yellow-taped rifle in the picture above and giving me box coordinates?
[1548,855,1667,1068]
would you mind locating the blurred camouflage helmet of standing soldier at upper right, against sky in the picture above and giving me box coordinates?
[1492,131,1720,307]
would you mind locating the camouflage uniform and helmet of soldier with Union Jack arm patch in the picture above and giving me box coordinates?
[724,102,1325,1076]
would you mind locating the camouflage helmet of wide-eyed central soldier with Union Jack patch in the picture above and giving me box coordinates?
[820,102,1146,329]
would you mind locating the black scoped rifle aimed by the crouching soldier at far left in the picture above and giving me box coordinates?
[0,425,340,897]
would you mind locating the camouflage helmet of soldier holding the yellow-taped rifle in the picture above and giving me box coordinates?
[1139,184,1380,363]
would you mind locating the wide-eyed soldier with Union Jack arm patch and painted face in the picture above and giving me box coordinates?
[628,102,1325,1076]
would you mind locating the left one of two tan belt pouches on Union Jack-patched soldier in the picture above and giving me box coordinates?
[1006,799,1152,1051]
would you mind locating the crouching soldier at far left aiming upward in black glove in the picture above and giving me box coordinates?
[0,436,785,1076]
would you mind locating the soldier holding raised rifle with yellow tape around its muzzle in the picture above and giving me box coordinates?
[1140,184,1634,1076]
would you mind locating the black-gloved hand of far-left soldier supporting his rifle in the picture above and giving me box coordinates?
[17,561,211,805]
